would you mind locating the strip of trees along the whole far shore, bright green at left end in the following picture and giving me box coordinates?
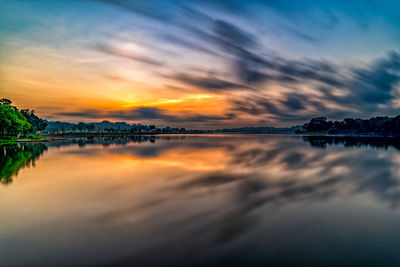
[0,98,400,145]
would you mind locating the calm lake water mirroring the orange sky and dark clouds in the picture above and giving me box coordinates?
[0,135,400,266]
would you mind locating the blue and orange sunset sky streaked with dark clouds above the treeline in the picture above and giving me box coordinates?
[0,0,400,129]
